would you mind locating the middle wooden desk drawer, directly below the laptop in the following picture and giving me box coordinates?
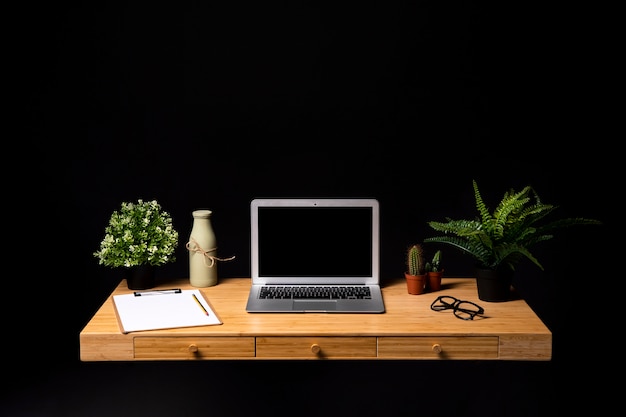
[256,337,376,359]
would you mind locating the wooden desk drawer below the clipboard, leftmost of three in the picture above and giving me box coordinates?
[134,336,254,359]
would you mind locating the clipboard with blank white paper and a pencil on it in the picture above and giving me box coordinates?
[113,288,222,333]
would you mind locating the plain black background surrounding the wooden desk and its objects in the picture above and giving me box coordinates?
[1,1,619,416]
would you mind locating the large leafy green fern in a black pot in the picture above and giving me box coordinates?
[424,180,602,301]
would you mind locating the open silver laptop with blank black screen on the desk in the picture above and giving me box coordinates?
[246,198,385,313]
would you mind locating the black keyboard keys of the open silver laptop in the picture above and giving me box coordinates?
[259,285,372,300]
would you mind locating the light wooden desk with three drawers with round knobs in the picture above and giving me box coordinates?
[80,278,552,361]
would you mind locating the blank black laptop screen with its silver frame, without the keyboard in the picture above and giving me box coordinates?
[252,199,379,284]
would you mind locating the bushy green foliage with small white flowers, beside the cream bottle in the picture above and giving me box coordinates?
[93,199,178,268]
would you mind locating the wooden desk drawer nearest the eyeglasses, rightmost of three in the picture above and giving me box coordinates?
[378,336,499,359]
